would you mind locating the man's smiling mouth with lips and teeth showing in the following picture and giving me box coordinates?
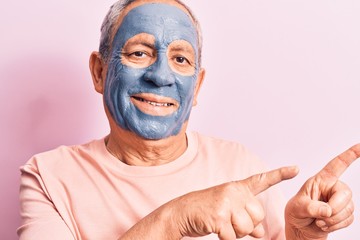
[131,93,179,116]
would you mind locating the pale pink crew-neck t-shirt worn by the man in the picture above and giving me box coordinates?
[18,132,285,240]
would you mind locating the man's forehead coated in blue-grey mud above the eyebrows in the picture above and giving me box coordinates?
[114,2,197,48]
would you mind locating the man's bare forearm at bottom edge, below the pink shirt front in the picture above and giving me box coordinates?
[118,204,182,240]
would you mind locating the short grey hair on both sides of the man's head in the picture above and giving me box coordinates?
[99,0,203,66]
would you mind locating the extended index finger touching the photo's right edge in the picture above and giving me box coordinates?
[318,143,360,178]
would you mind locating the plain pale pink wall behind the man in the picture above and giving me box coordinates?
[0,0,360,239]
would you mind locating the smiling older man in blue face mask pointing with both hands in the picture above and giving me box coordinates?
[18,0,360,240]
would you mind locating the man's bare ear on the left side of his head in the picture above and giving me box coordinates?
[89,52,107,94]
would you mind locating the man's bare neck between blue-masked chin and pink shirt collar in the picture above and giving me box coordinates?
[105,124,187,166]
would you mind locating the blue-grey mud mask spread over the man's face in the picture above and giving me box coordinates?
[104,3,199,140]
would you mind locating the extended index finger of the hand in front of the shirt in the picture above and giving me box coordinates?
[244,167,299,195]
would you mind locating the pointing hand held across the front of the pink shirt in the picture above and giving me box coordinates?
[166,167,298,240]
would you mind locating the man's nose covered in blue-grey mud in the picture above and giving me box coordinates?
[144,53,175,87]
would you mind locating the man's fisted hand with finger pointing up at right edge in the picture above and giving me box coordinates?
[285,144,360,240]
